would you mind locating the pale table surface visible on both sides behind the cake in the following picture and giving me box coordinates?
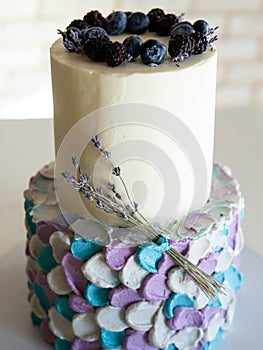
[0,109,263,258]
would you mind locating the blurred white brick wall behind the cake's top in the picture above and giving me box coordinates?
[0,0,263,118]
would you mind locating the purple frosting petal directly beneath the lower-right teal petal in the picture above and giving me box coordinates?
[168,306,204,331]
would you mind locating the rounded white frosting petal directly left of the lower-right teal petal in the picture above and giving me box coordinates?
[125,301,160,332]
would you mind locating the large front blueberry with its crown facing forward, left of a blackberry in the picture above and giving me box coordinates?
[140,39,166,67]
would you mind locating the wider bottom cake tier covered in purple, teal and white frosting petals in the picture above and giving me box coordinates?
[25,164,244,350]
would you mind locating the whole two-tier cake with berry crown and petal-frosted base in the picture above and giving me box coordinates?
[25,9,244,350]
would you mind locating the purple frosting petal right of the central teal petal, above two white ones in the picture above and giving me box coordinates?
[110,286,144,308]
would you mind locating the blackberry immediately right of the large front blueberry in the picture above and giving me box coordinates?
[168,34,195,61]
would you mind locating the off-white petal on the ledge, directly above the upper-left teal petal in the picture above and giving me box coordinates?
[71,219,110,245]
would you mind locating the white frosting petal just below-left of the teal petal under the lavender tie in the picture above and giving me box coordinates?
[119,255,149,289]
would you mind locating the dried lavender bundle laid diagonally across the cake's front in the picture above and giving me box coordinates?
[62,135,224,298]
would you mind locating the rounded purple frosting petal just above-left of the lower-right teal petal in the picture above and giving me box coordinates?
[140,273,172,302]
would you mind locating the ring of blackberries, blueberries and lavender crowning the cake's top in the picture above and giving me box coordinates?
[58,9,218,68]
